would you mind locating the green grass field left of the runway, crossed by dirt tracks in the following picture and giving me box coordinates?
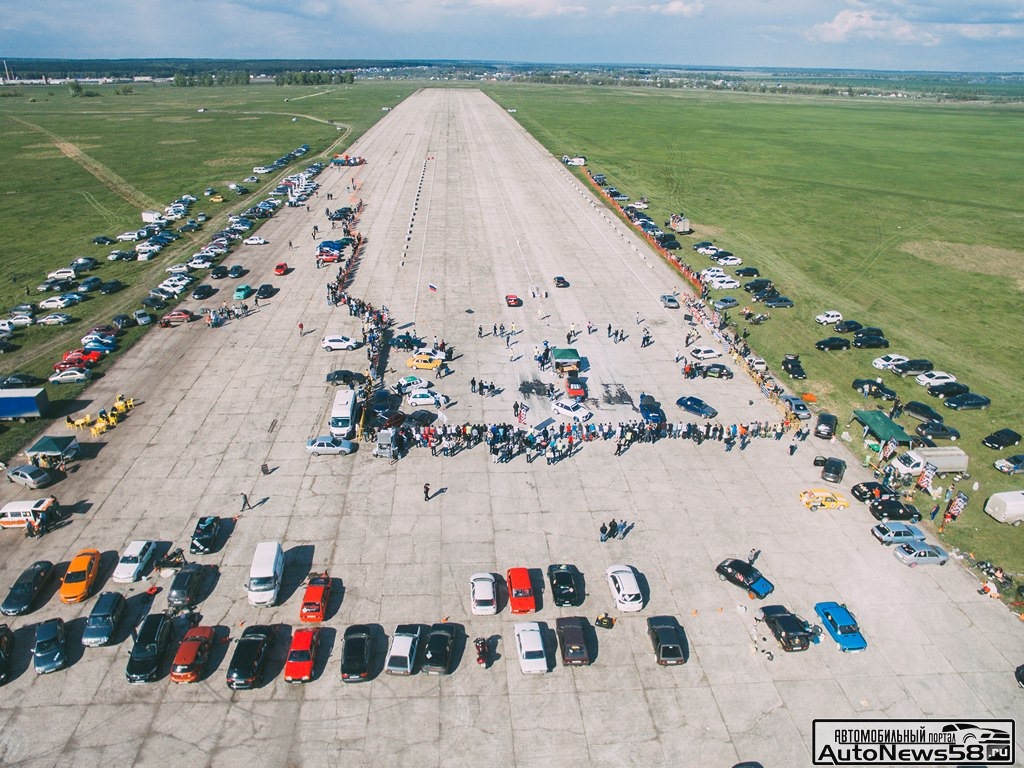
[0,83,415,461]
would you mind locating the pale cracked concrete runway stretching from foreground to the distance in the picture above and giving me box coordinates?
[0,89,1024,767]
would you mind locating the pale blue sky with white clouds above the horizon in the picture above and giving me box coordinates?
[0,0,1024,72]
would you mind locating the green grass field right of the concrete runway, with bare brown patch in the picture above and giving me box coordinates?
[487,87,1024,572]
